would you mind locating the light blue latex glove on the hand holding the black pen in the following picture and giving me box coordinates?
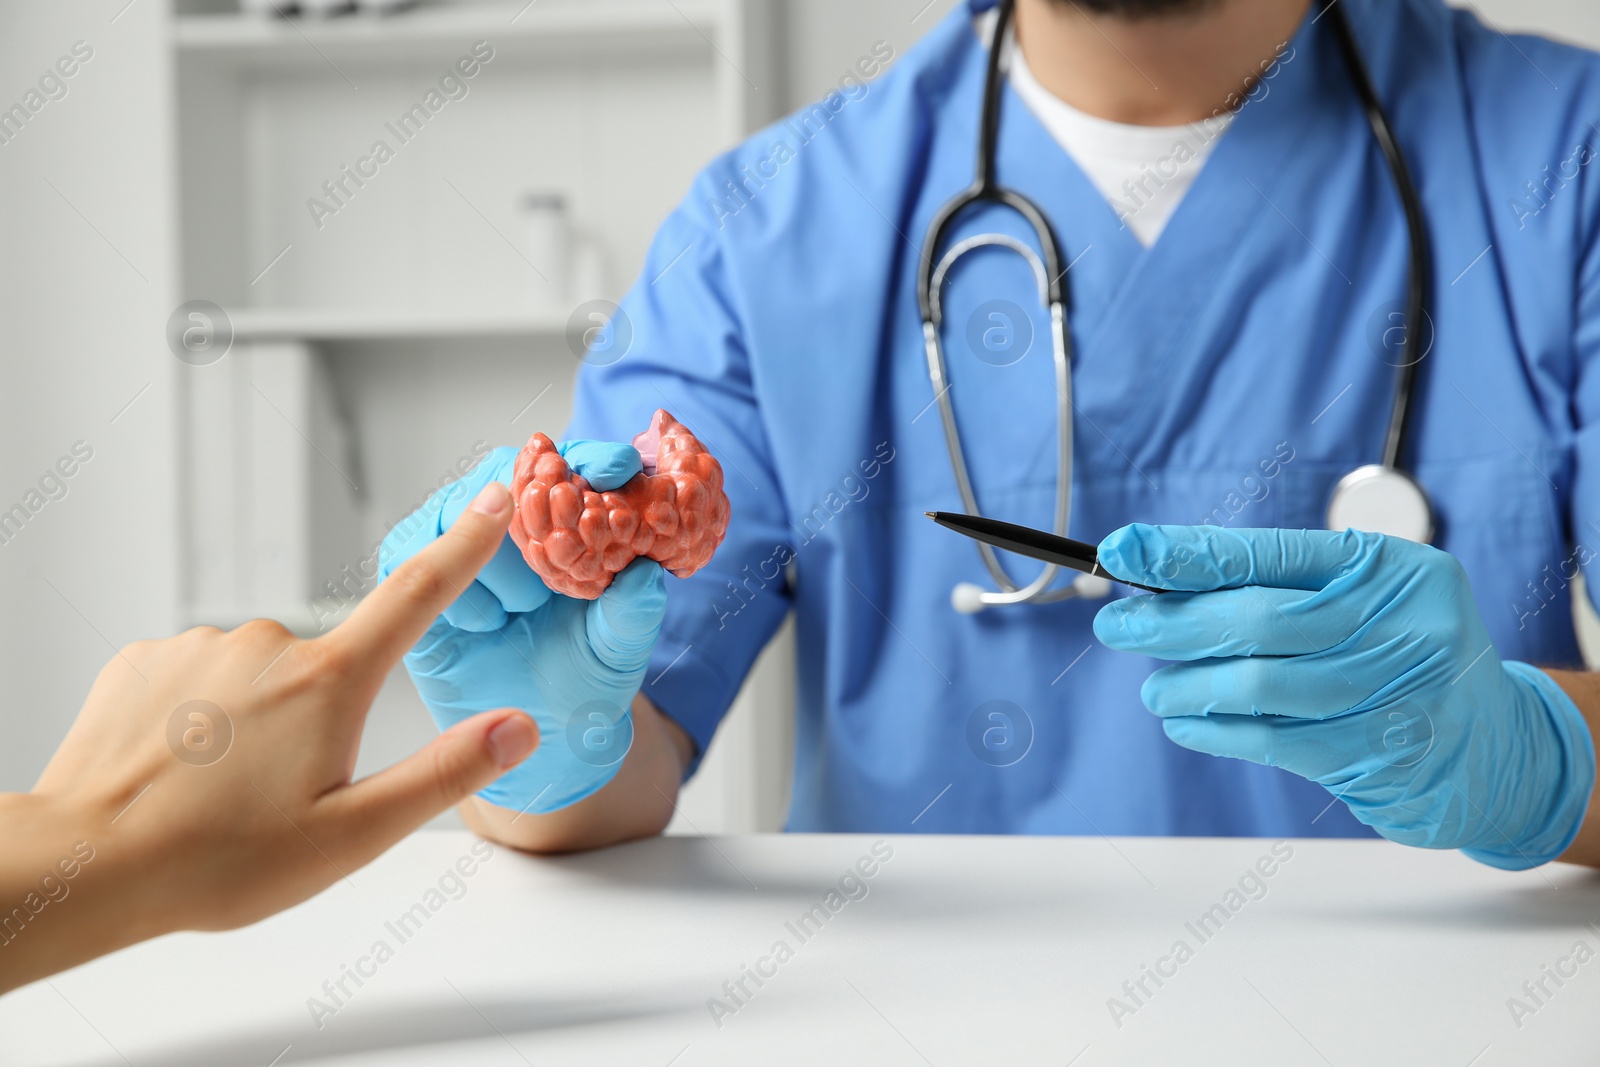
[1094,525,1595,870]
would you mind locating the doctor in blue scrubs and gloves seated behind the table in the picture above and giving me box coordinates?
[384,0,1600,869]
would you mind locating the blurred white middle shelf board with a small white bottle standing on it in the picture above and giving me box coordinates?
[229,307,566,341]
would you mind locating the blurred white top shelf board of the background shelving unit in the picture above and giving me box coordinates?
[173,0,726,66]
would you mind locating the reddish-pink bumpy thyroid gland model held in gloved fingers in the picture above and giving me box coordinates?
[510,411,728,600]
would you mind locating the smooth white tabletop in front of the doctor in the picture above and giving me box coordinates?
[0,832,1600,1067]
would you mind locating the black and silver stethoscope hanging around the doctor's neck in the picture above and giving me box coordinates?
[917,0,1434,614]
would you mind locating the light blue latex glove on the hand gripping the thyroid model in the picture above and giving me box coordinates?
[378,442,667,814]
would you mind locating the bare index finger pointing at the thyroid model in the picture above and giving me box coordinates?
[317,482,512,672]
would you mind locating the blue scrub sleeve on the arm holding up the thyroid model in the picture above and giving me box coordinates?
[566,189,792,774]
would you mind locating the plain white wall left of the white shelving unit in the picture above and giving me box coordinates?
[0,0,178,790]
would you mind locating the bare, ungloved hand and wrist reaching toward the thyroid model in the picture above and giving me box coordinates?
[0,483,538,992]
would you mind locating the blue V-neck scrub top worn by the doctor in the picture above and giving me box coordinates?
[568,0,1600,837]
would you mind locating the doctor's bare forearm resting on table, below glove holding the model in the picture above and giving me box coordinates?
[459,696,694,853]
